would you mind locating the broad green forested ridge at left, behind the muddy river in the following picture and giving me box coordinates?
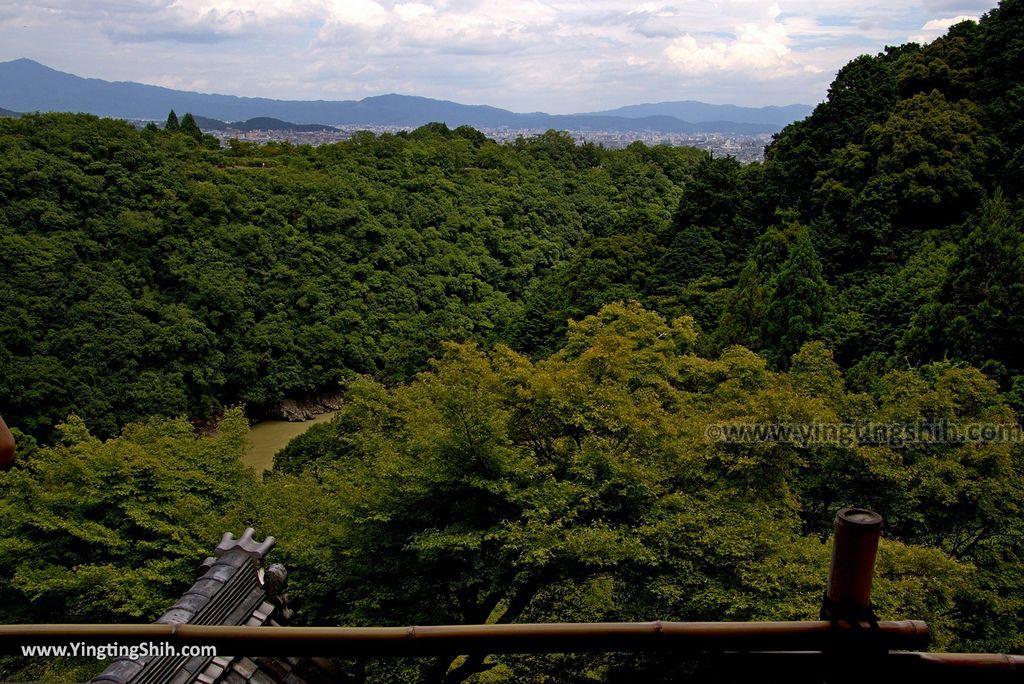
[0,115,699,436]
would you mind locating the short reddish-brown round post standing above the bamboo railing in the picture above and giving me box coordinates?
[821,508,882,619]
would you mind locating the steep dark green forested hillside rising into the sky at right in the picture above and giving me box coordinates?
[519,2,1024,395]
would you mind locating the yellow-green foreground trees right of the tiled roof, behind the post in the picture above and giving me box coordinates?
[263,303,1024,681]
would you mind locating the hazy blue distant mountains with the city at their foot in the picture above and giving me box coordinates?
[0,59,812,134]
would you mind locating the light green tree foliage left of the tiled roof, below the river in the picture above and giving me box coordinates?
[0,410,257,680]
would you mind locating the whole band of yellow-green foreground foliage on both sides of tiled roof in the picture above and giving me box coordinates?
[0,302,1024,681]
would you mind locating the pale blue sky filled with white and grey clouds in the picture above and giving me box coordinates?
[0,0,996,114]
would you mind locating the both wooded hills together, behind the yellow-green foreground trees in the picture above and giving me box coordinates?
[8,3,1024,436]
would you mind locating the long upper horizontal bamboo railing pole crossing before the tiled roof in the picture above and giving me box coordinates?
[0,621,929,656]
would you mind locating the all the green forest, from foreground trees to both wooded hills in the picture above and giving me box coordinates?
[0,0,1024,682]
